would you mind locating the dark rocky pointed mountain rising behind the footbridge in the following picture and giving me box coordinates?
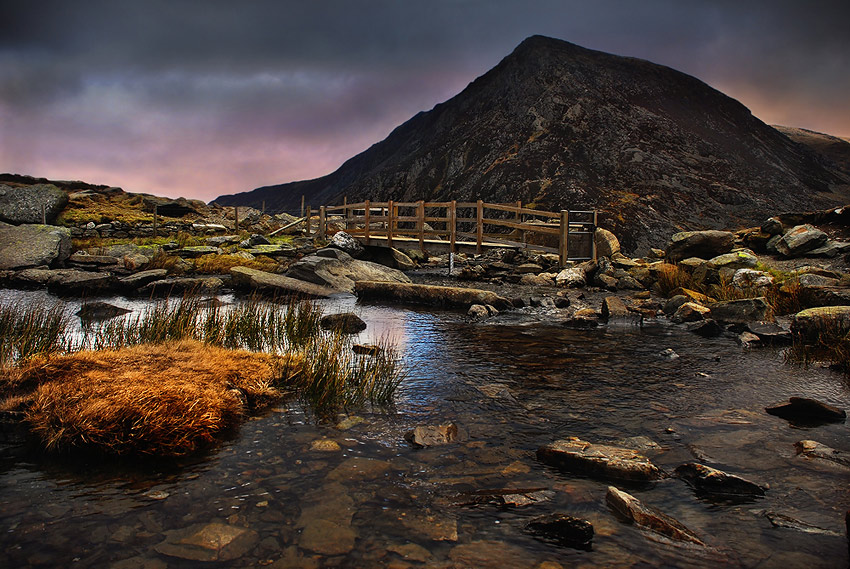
[215,36,850,252]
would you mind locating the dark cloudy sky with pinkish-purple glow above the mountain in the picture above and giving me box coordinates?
[0,0,850,201]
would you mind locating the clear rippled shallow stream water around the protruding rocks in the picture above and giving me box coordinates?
[0,291,850,568]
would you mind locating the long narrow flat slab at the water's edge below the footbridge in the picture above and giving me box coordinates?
[355,281,506,310]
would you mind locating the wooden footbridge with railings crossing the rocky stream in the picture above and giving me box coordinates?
[299,200,596,266]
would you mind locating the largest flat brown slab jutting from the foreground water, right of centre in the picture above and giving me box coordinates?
[537,437,664,481]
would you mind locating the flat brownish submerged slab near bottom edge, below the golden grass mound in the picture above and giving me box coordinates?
[154,523,258,561]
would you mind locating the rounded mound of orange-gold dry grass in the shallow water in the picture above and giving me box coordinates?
[7,340,299,456]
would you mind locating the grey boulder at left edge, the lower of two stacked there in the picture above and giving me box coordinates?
[0,225,71,270]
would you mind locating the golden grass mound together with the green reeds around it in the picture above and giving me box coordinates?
[0,297,403,456]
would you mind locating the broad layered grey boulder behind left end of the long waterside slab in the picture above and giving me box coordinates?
[286,255,410,292]
